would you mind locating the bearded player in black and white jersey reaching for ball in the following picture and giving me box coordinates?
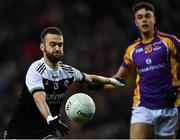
[4,27,124,139]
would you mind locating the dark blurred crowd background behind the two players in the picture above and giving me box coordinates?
[0,0,180,138]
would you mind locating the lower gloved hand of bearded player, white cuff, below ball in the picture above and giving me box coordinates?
[47,116,69,136]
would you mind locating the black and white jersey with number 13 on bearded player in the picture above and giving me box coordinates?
[5,58,84,135]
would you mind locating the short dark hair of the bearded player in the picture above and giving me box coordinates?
[40,27,62,42]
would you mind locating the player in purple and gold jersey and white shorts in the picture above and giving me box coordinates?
[114,2,180,139]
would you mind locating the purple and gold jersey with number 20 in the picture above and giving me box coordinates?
[122,31,180,109]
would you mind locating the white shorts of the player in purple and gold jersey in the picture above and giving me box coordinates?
[131,107,178,136]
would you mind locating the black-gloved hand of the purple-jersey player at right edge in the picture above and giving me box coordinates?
[166,86,180,105]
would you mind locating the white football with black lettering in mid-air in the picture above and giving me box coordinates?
[65,93,96,123]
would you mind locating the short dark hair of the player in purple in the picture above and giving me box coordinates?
[132,2,155,15]
